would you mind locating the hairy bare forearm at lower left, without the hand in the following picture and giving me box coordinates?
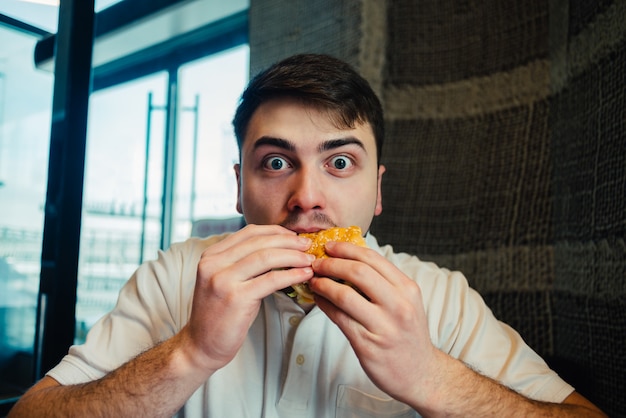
[10,333,212,418]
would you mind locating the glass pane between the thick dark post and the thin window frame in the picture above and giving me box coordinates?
[75,73,167,343]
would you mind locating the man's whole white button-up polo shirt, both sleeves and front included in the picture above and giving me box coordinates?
[48,235,573,418]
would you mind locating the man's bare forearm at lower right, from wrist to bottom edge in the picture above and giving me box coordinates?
[413,353,605,417]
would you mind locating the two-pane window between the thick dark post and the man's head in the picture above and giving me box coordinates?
[75,45,248,343]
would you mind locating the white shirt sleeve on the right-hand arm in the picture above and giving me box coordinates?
[372,240,574,402]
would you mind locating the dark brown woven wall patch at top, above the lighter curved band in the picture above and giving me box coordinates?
[387,0,549,85]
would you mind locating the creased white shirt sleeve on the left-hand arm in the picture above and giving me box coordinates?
[47,239,211,385]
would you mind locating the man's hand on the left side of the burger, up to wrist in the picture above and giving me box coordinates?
[184,225,315,371]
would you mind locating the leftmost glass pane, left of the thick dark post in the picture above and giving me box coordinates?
[0,27,54,401]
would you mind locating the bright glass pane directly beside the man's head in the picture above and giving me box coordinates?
[173,45,249,241]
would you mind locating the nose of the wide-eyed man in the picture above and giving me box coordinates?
[287,167,326,212]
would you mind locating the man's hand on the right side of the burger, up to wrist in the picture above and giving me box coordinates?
[309,243,441,404]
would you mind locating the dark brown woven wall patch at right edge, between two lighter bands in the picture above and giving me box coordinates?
[551,42,626,240]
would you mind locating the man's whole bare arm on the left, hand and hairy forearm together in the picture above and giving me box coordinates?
[10,225,313,418]
